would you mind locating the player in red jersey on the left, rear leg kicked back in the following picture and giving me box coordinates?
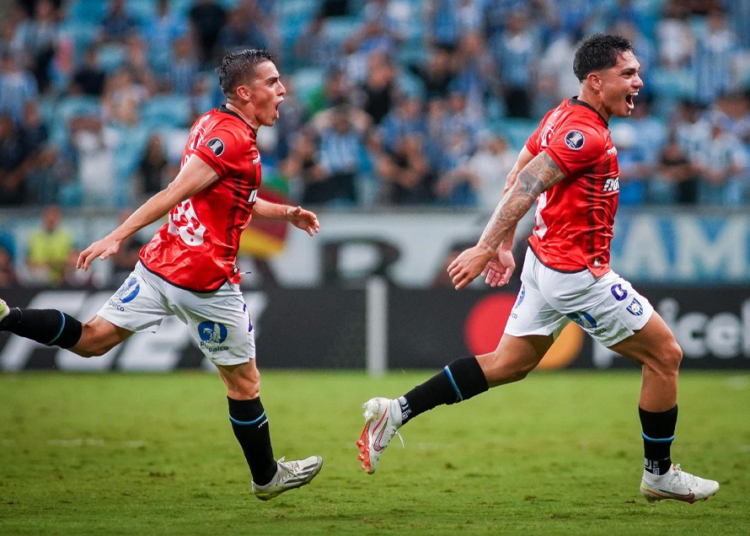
[0,50,323,500]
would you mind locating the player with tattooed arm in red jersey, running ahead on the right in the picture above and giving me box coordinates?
[357,34,719,502]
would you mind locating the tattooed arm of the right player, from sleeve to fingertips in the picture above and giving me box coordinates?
[448,152,565,290]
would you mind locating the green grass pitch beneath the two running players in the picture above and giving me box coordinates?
[0,371,750,536]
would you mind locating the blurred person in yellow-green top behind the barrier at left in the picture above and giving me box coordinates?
[26,205,73,285]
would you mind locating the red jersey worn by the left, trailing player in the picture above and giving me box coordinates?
[140,106,261,292]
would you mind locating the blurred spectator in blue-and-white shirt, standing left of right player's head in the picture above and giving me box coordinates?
[490,10,541,117]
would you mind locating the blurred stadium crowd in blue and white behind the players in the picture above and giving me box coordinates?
[0,0,750,286]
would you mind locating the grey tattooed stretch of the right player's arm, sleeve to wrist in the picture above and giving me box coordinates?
[479,152,565,252]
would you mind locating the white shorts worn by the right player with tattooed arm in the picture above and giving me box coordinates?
[505,248,654,347]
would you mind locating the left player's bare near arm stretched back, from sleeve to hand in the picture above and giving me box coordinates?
[76,157,219,271]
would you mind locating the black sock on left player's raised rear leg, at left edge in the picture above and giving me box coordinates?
[0,307,83,348]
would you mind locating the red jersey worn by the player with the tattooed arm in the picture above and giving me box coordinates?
[526,98,620,277]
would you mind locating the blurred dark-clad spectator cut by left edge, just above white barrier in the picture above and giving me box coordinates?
[0,113,28,206]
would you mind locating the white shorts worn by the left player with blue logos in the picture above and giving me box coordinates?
[97,262,255,365]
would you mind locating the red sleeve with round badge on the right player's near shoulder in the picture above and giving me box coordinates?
[545,123,606,177]
